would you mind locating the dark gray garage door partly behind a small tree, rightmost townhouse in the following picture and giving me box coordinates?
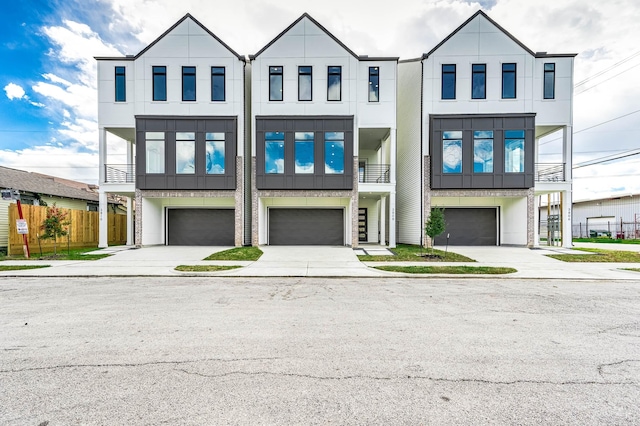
[436,208,498,246]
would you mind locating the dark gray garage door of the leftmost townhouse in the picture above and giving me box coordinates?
[167,209,235,246]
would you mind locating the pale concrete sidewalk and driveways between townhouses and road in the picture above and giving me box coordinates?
[0,244,640,281]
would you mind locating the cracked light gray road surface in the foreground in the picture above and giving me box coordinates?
[0,278,640,426]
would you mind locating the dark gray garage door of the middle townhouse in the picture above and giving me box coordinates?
[269,209,344,246]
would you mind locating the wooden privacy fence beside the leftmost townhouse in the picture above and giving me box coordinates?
[8,204,127,254]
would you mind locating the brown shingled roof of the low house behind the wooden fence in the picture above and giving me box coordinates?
[0,166,98,202]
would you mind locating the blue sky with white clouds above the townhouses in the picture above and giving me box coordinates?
[0,0,640,199]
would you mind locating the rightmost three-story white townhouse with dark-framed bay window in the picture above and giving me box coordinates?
[397,11,576,247]
